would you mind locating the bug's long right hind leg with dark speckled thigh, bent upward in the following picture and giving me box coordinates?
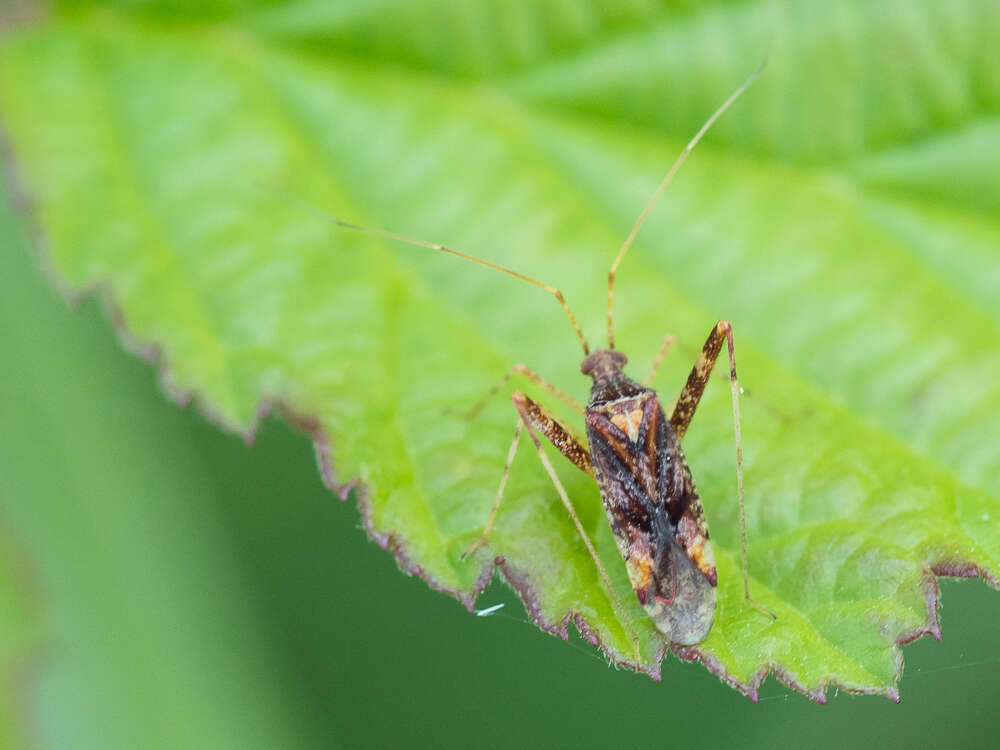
[670,320,777,619]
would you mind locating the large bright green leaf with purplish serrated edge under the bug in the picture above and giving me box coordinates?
[0,2,1000,700]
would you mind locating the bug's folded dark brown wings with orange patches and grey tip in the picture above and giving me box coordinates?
[587,391,717,645]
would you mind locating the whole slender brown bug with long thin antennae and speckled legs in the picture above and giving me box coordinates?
[304,65,775,664]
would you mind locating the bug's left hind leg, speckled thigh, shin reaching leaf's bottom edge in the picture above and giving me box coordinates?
[512,392,640,666]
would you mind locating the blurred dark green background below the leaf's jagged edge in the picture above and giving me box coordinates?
[0,175,1000,749]
